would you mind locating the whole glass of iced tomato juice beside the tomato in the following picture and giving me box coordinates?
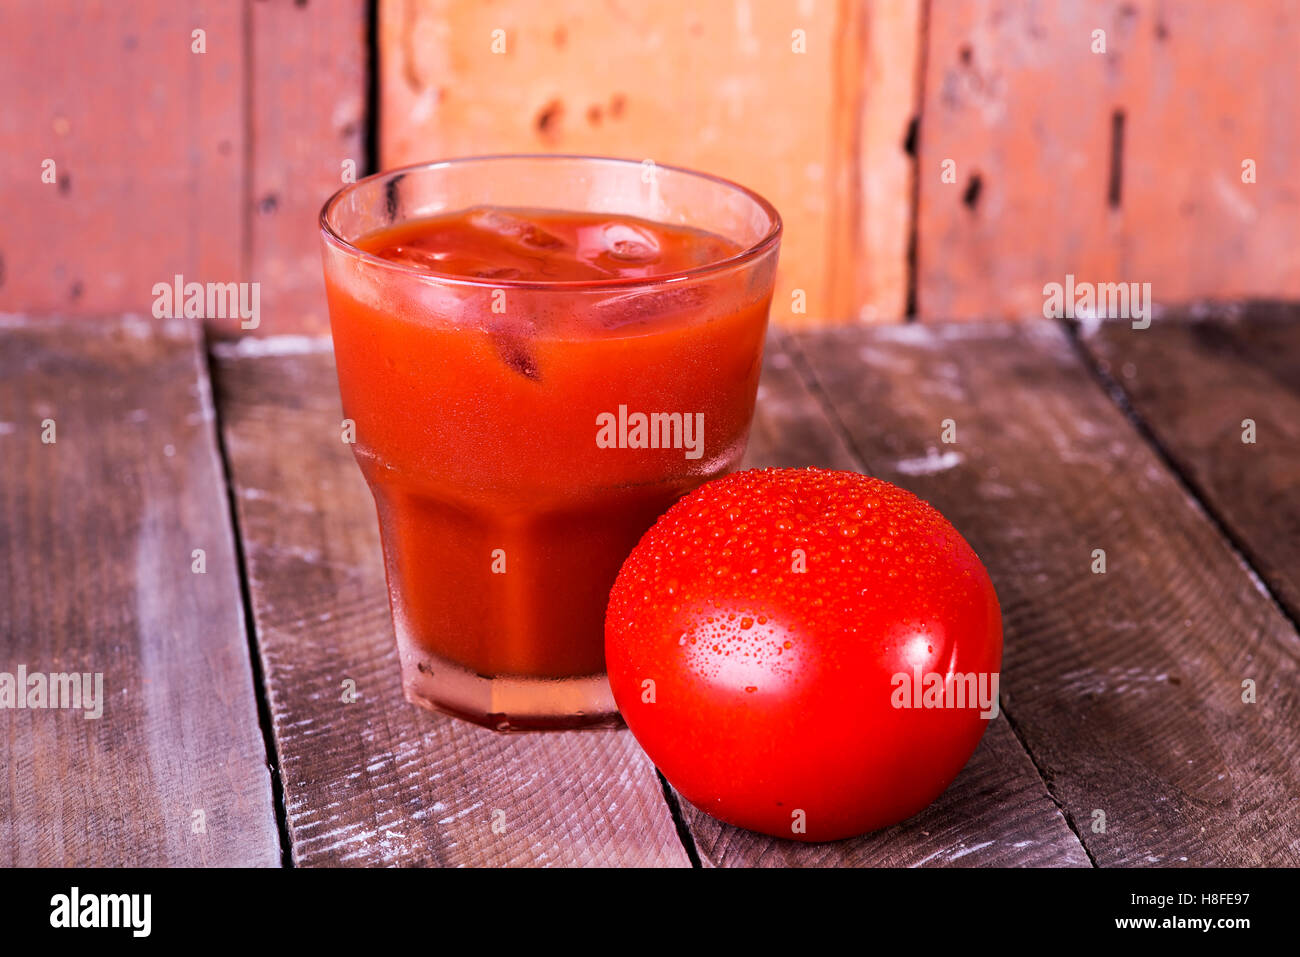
[320,155,781,731]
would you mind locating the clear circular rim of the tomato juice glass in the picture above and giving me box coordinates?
[317,153,784,291]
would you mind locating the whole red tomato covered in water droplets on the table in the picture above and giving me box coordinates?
[606,468,1002,841]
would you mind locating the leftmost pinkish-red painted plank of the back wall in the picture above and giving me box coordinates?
[0,0,244,323]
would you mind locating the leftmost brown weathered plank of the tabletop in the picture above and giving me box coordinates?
[0,317,280,867]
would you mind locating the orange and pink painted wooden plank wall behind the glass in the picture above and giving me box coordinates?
[0,0,1300,334]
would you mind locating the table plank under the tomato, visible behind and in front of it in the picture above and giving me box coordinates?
[679,333,1088,867]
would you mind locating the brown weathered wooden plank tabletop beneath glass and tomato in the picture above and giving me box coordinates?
[0,306,1300,867]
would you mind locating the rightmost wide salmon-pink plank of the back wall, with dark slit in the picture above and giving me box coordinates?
[917,0,1300,320]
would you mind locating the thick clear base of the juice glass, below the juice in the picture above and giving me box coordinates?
[398,633,625,731]
